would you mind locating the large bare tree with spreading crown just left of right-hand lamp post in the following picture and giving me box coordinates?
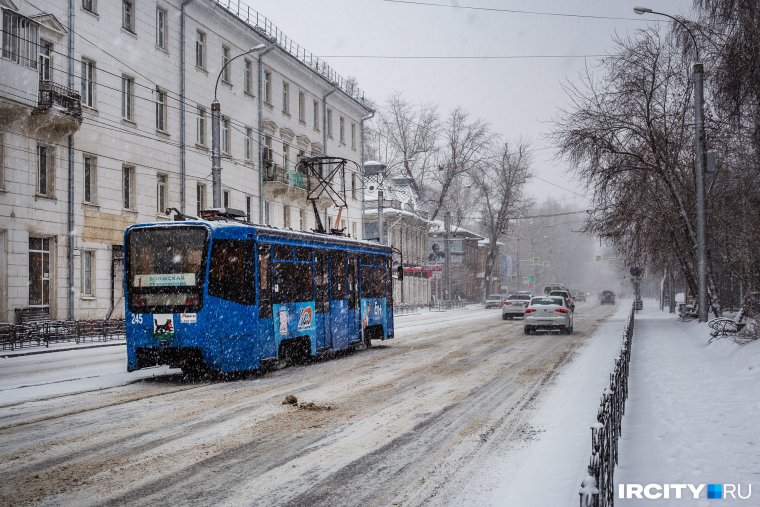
[554,29,720,314]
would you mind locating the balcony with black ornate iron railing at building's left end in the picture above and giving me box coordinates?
[32,81,82,135]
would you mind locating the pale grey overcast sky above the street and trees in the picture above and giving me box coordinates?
[252,0,692,209]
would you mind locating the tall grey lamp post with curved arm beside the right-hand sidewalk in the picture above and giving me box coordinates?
[633,7,707,322]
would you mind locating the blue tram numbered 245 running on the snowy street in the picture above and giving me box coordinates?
[124,212,393,373]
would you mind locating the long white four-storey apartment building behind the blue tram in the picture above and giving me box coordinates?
[0,0,370,322]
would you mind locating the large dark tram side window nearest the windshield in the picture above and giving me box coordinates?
[208,239,256,305]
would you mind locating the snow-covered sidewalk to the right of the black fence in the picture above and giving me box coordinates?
[615,300,760,506]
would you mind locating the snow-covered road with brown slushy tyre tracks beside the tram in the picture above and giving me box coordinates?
[0,303,615,505]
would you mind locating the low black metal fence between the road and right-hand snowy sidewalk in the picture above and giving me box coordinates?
[579,306,635,507]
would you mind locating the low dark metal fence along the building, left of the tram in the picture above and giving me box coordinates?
[0,320,126,350]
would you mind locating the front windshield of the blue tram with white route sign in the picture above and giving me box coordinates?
[127,227,208,313]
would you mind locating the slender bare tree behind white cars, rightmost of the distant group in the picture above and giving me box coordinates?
[471,141,531,297]
